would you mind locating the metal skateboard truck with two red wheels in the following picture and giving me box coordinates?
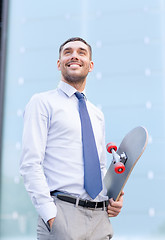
[106,142,127,174]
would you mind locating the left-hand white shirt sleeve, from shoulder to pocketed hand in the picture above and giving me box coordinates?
[20,94,57,222]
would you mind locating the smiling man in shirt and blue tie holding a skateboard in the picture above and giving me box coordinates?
[20,38,124,240]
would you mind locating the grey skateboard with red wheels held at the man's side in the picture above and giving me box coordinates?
[104,126,148,201]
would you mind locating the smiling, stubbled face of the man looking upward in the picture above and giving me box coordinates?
[57,41,93,83]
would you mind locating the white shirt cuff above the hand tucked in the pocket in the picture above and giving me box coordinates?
[37,202,57,223]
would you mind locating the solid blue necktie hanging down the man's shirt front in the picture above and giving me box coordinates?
[75,92,102,199]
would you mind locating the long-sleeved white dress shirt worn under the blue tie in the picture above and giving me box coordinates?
[20,81,107,222]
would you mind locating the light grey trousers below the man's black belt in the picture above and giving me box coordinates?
[37,196,113,240]
